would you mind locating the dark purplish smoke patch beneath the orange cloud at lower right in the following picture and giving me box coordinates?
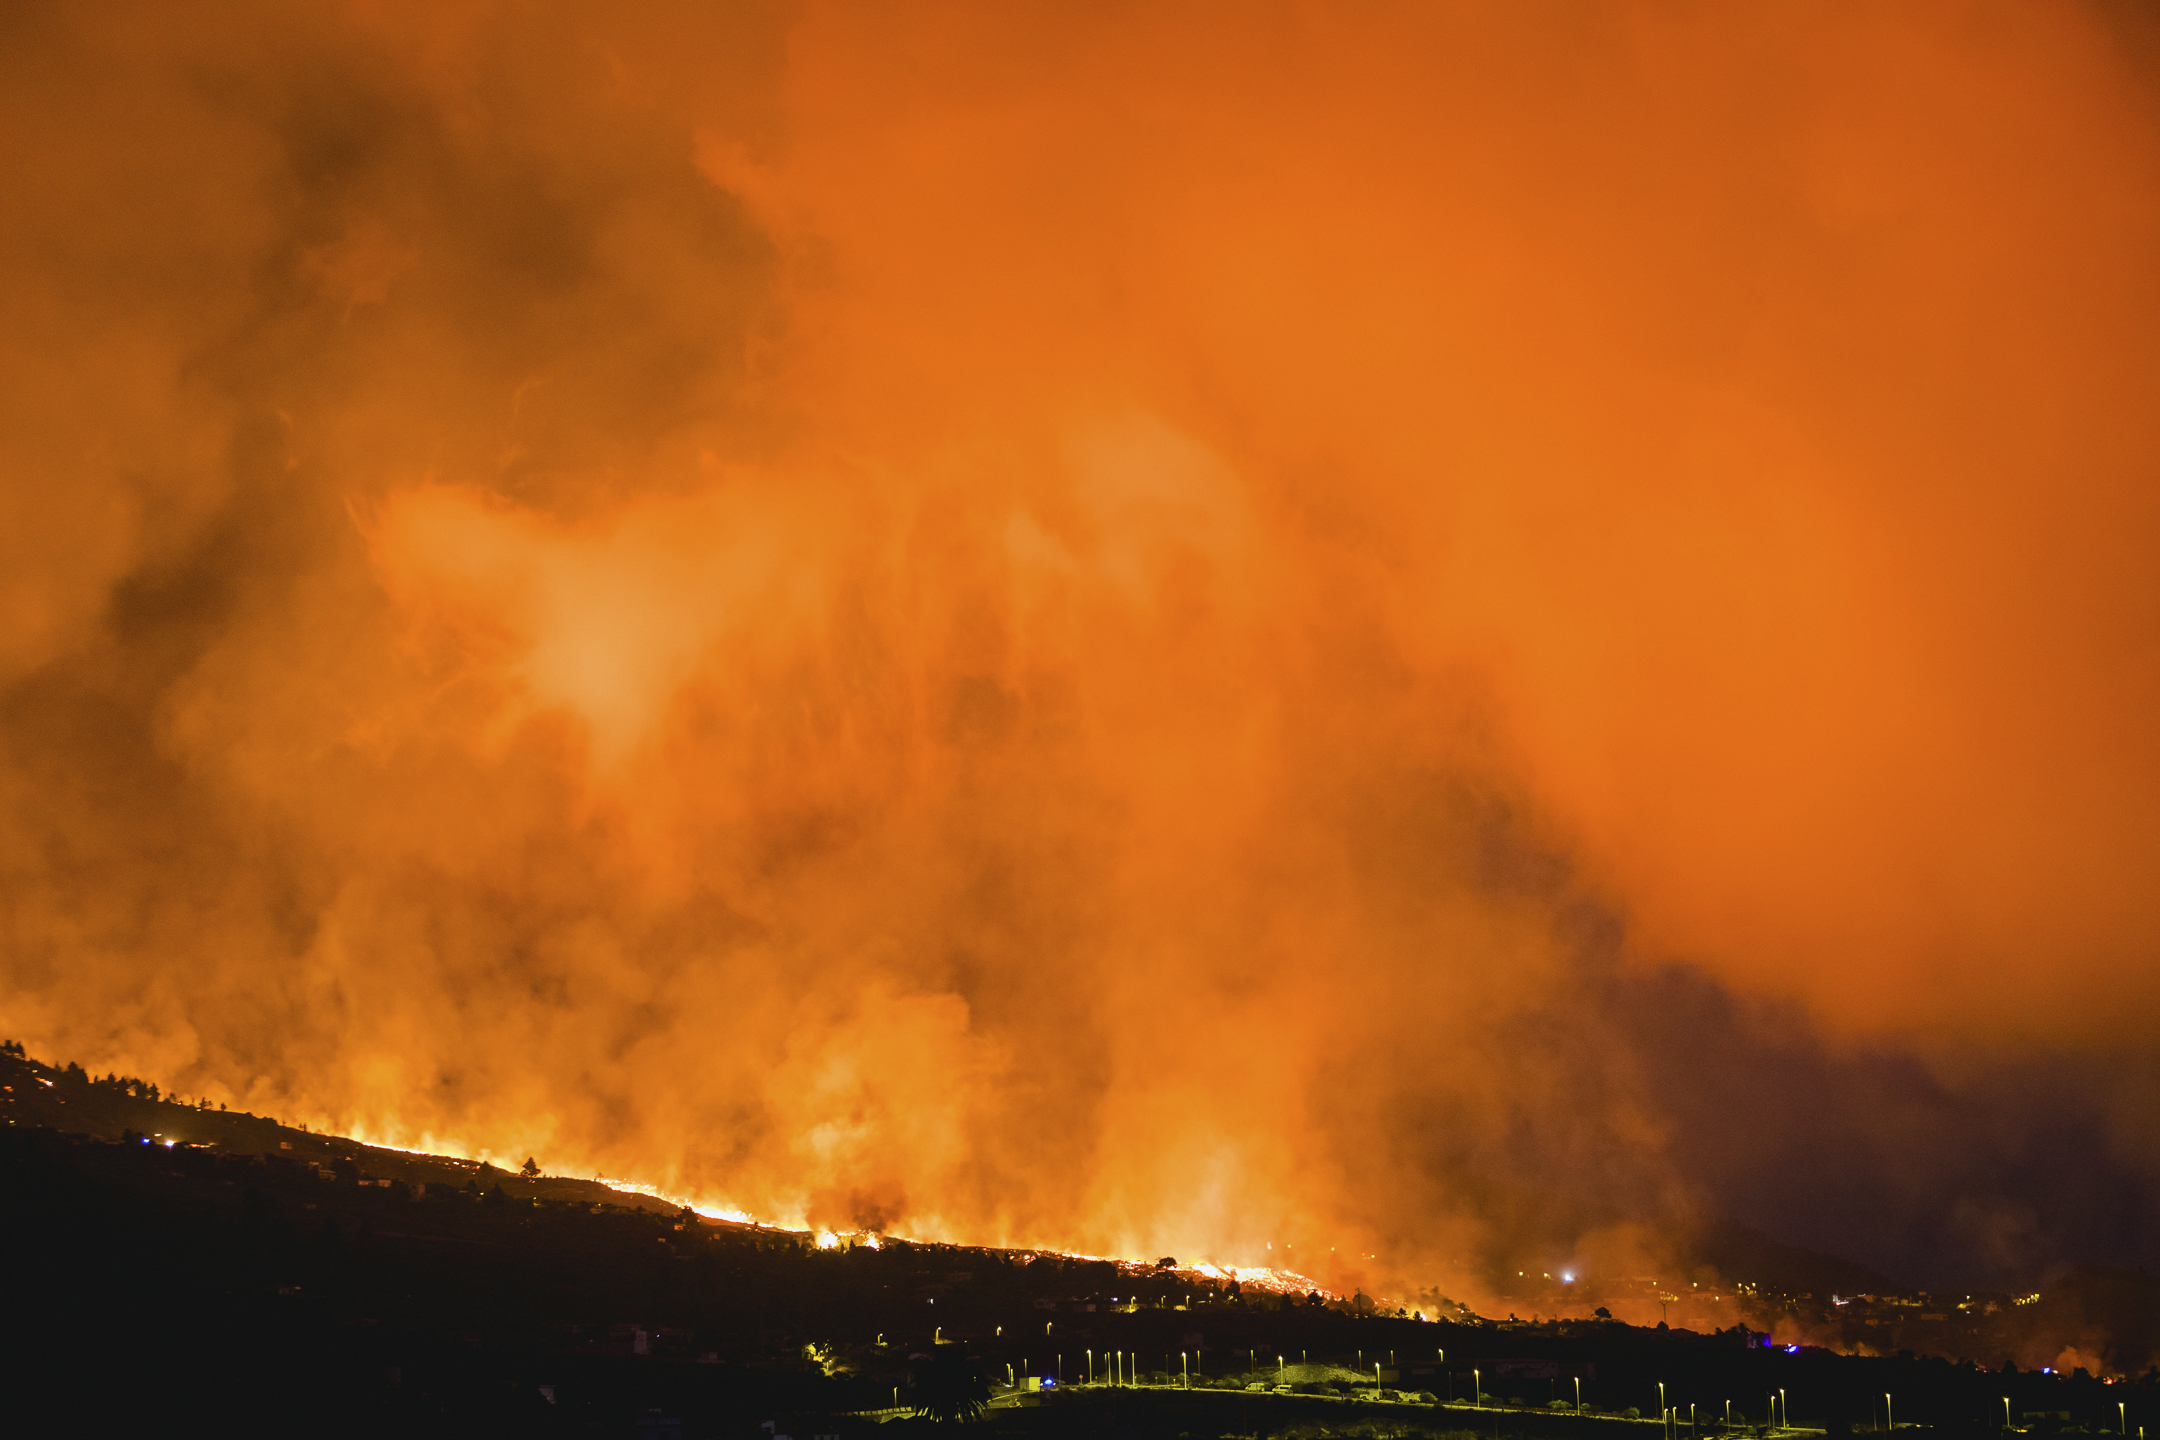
[1609,969,2160,1293]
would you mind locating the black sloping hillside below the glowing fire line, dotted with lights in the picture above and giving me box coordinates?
[0,1054,2160,1440]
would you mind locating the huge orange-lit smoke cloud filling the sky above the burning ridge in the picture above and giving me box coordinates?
[0,4,2160,1298]
